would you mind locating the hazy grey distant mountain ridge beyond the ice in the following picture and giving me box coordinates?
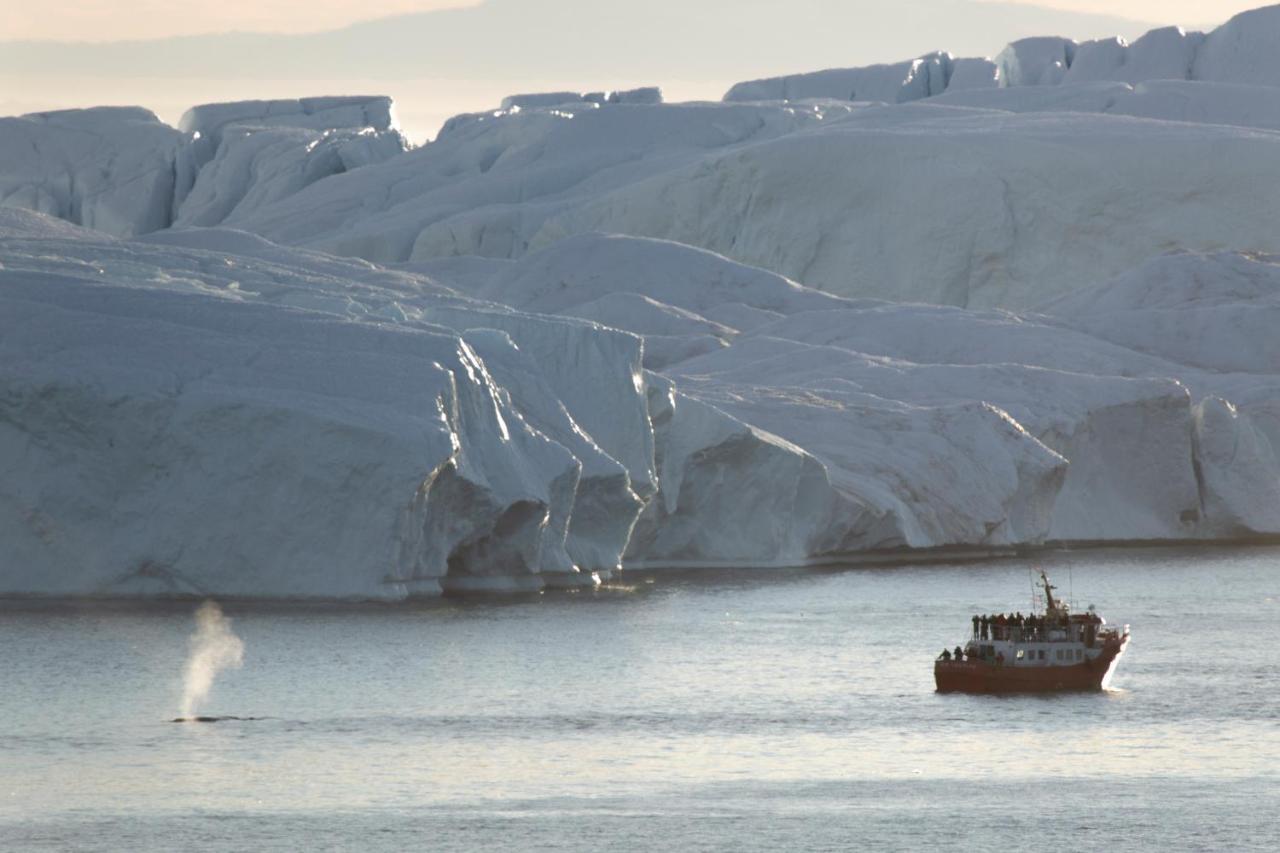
[0,0,1149,85]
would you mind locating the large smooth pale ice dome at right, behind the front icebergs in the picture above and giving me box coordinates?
[532,105,1280,307]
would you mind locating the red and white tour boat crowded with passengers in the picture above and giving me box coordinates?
[933,570,1129,693]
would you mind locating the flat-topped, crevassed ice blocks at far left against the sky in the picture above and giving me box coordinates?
[0,97,408,237]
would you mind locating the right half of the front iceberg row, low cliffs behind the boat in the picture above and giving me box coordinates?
[458,234,1280,548]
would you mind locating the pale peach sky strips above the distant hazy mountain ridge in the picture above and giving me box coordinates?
[0,0,1265,41]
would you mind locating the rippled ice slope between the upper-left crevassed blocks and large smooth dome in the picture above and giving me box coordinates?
[237,97,851,263]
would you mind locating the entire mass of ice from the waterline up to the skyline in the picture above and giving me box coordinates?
[0,8,1280,598]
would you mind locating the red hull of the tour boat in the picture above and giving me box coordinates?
[933,635,1129,693]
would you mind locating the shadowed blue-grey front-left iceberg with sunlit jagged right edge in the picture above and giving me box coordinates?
[0,225,652,598]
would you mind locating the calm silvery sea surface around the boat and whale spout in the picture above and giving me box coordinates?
[0,548,1280,853]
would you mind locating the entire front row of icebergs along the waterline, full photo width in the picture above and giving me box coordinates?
[0,211,1280,598]
